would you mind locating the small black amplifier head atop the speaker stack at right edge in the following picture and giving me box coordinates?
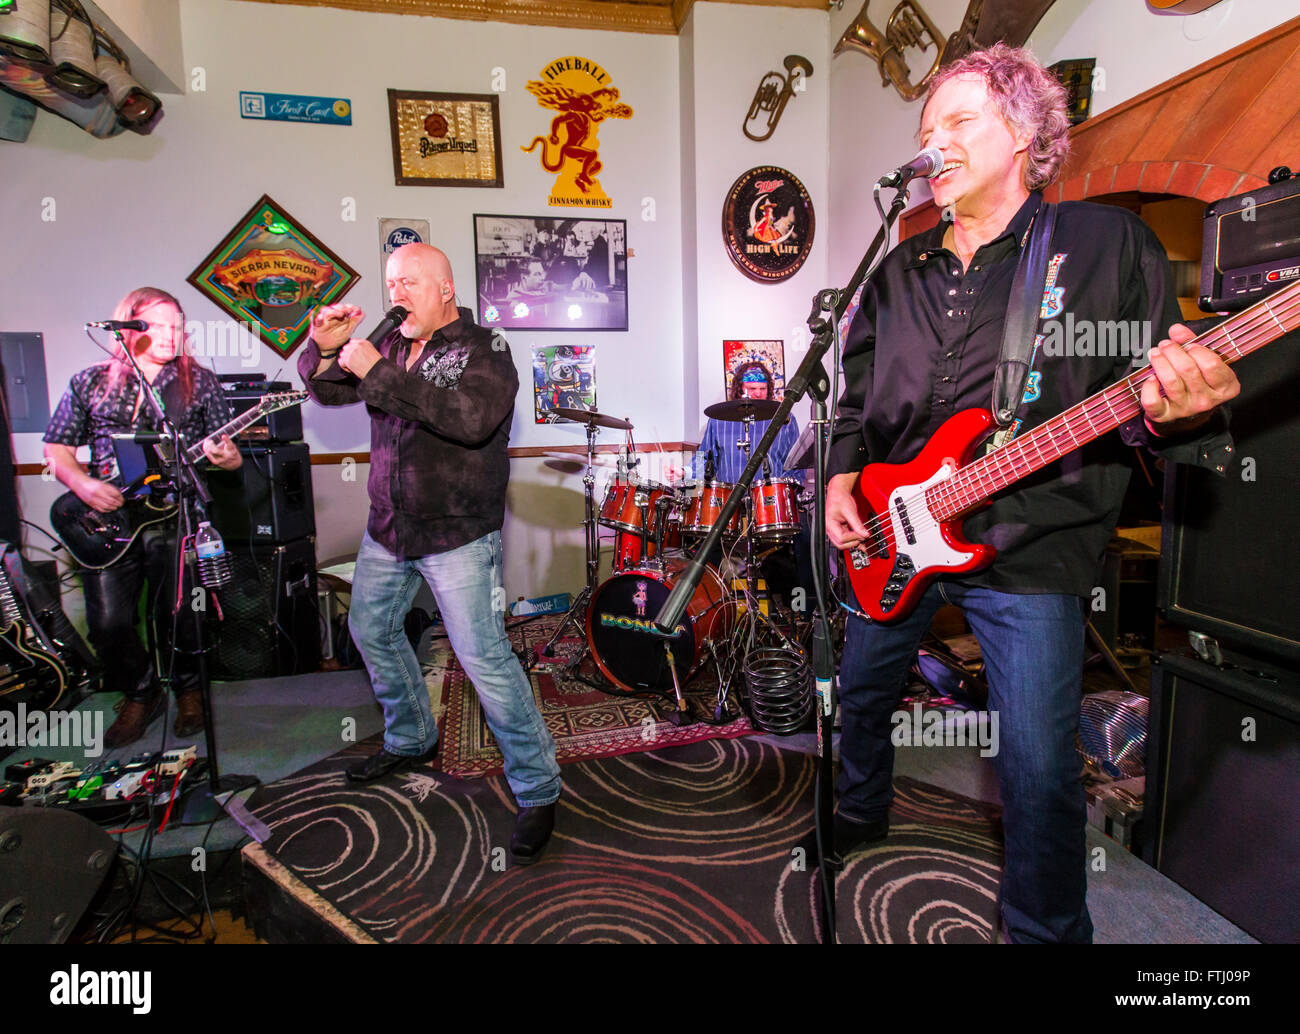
[1199,177,1300,312]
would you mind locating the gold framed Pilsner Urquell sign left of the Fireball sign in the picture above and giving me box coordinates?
[389,90,506,187]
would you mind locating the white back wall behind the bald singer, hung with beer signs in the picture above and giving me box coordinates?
[0,0,694,602]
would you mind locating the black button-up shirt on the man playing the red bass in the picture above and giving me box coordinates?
[829,194,1231,596]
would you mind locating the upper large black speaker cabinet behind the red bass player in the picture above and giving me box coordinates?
[1158,332,1300,666]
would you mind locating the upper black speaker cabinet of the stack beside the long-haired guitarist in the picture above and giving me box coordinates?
[208,442,316,545]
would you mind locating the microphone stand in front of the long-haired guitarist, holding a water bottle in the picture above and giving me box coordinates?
[113,330,259,825]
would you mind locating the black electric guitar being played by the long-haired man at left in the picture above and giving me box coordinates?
[49,391,307,571]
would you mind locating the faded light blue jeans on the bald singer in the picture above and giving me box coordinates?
[348,532,560,808]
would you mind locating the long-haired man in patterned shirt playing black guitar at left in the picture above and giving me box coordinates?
[44,287,243,748]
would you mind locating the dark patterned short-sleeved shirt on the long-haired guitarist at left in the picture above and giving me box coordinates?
[44,359,230,488]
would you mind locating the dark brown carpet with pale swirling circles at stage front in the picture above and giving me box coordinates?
[250,737,1001,943]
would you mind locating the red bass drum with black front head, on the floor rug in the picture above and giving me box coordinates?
[586,553,736,693]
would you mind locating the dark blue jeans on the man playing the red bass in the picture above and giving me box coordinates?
[839,581,1092,943]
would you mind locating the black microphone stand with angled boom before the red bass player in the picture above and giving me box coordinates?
[654,185,909,944]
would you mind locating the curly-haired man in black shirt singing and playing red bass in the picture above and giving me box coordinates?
[827,44,1239,942]
